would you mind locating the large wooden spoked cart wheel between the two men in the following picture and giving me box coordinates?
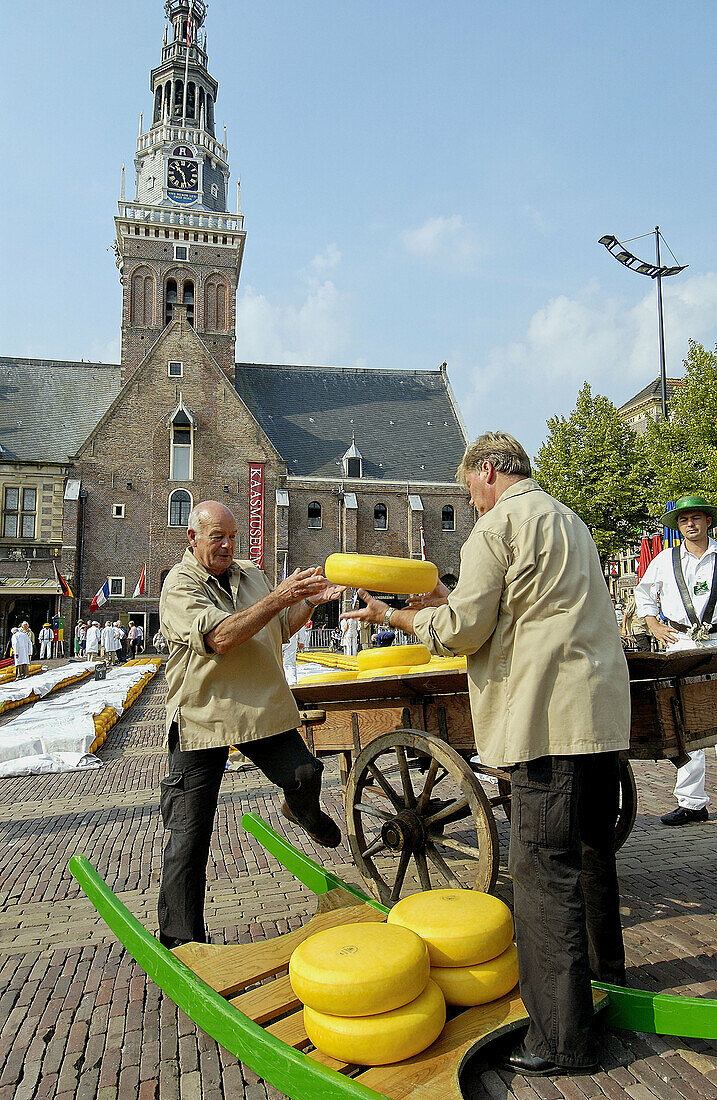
[346,729,499,905]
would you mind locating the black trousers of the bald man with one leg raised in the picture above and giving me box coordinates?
[157,724,323,944]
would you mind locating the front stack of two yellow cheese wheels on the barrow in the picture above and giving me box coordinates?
[289,923,445,1066]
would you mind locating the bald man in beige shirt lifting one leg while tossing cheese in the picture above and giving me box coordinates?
[158,501,343,947]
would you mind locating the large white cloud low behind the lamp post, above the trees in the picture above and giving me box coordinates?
[452,273,717,453]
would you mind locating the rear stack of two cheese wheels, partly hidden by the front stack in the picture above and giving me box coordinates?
[388,890,518,1005]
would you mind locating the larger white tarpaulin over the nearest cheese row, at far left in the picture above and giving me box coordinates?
[0,664,156,777]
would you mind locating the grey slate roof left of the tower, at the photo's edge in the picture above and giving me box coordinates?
[0,355,120,462]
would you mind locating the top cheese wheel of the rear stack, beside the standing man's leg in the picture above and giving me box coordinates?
[388,890,512,966]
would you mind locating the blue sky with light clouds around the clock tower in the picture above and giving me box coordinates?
[0,0,717,453]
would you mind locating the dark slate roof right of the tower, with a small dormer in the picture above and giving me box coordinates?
[235,363,466,482]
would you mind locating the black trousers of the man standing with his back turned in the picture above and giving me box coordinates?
[509,752,625,1066]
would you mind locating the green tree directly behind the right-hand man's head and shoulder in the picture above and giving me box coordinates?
[534,382,648,563]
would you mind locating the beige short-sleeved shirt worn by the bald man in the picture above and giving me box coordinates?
[159,549,299,749]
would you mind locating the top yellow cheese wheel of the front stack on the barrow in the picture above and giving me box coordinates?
[289,923,430,1016]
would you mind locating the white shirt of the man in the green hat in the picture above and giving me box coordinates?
[635,539,717,626]
